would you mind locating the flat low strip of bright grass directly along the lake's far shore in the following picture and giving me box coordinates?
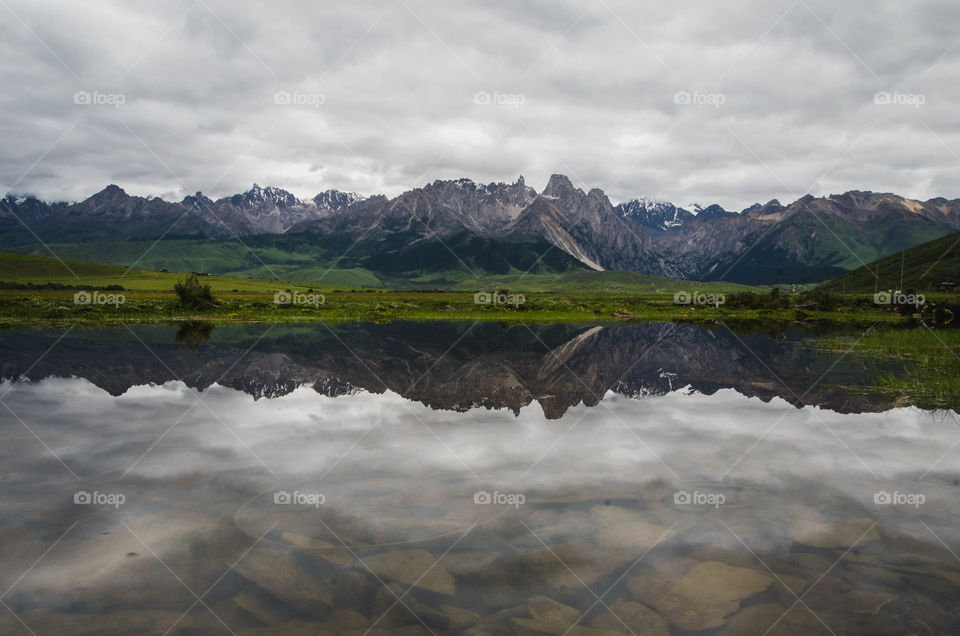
[0,290,905,328]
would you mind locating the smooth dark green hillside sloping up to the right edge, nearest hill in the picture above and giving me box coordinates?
[819,233,960,294]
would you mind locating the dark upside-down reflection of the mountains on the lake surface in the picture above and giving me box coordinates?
[0,323,920,419]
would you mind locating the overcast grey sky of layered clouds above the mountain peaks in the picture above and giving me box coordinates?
[0,0,960,209]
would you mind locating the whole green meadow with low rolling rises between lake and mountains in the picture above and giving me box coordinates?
[0,253,928,326]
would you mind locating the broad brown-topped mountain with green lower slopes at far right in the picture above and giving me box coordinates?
[654,191,960,284]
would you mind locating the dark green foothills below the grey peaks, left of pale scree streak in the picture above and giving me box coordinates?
[16,233,584,289]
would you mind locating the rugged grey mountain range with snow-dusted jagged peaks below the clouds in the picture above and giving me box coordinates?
[0,174,960,284]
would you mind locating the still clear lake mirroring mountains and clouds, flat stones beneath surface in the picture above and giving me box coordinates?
[0,323,960,636]
